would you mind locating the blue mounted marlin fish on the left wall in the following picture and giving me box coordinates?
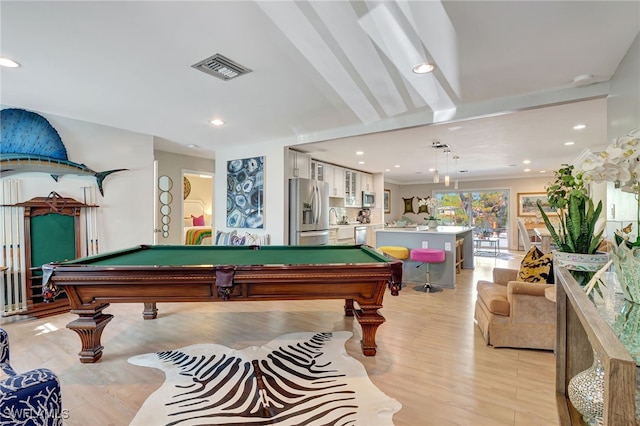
[0,108,127,196]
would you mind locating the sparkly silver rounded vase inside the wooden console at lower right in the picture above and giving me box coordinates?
[567,351,604,426]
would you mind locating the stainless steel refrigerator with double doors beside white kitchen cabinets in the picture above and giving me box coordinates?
[289,178,329,246]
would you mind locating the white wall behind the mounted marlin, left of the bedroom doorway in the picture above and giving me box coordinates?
[0,112,153,253]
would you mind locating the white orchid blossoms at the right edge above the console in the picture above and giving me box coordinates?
[577,129,640,194]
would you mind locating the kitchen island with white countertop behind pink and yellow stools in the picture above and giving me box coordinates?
[376,226,474,288]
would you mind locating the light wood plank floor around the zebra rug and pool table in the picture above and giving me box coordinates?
[2,252,558,426]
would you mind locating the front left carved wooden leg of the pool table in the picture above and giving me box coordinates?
[67,303,113,364]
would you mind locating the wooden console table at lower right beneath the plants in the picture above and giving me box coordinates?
[555,267,637,426]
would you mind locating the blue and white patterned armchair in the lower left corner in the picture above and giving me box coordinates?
[0,328,64,426]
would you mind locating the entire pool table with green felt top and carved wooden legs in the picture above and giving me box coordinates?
[43,245,402,363]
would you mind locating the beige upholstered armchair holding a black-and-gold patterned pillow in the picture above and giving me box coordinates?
[475,268,556,350]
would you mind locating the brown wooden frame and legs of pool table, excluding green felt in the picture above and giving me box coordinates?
[50,261,402,363]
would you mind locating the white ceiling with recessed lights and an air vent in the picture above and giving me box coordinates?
[0,0,640,183]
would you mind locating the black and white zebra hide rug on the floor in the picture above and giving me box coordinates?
[129,331,402,426]
